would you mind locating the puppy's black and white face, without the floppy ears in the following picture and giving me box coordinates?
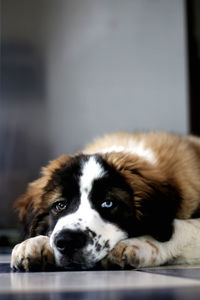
[46,156,134,268]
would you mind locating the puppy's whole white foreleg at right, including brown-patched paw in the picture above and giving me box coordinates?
[102,219,200,269]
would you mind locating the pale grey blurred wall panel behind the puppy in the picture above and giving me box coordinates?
[41,0,188,155]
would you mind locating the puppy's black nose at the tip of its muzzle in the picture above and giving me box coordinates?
[54,229,87,254]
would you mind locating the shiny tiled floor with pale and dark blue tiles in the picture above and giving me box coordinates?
[0,255,200,300]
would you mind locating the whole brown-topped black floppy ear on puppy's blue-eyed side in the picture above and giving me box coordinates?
[128,164,181,242]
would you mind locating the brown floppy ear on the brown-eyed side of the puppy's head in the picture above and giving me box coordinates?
[14,155,70,237]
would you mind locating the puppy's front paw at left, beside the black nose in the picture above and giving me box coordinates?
[11,235,55,271]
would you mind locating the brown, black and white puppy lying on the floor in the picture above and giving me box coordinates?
[11,132,200,271]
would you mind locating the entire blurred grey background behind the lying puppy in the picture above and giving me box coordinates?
[0,0,200,246]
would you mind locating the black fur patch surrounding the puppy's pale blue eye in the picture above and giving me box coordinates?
[89,156,135,233]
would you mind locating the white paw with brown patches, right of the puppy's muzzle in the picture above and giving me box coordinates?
[101,238,161,269]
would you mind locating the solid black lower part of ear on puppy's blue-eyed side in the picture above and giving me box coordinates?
[135,182,180,242]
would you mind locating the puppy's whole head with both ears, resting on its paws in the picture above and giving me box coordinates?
[17,153,180,269]
